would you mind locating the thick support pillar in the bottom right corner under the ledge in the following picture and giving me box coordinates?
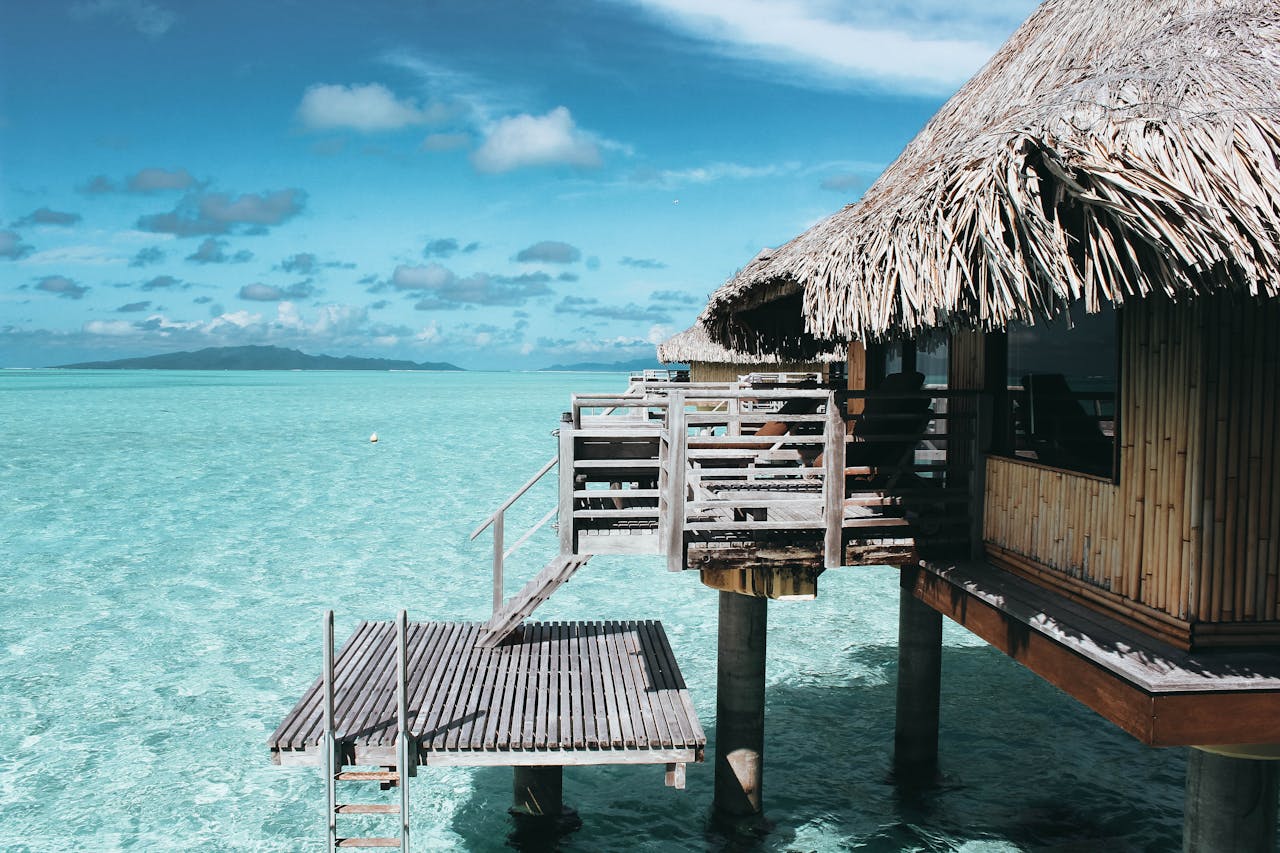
[1183,748,1280,853]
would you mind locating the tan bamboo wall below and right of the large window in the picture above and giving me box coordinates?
[984,297,1280,622]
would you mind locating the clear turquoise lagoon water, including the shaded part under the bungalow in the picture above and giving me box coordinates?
[0,371,1185,853]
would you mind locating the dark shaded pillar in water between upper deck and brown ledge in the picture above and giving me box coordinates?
[893,567,942,785]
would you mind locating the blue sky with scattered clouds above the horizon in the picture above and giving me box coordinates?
[0,0,1036,369]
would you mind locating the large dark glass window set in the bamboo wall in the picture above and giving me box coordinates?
[1001,305,1119,476]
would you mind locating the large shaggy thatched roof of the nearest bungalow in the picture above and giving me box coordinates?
[701,0,1280,353]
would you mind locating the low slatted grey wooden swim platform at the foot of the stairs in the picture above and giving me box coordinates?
[268,621,707,766]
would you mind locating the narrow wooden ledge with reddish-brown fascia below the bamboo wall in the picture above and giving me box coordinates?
[921,561,1280,747]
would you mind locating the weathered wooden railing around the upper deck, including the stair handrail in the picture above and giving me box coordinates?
[486,380,989,578]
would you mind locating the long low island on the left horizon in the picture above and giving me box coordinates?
[55,346,462,370]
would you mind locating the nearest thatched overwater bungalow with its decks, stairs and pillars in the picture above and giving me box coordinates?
[271,0,1280,850]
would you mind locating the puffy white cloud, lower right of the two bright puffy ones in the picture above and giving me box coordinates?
[471,106,600,173]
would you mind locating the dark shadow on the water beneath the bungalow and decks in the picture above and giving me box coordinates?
[442,638,1185,853]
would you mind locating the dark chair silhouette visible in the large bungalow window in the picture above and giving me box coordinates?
[1018,373,1115,475]
